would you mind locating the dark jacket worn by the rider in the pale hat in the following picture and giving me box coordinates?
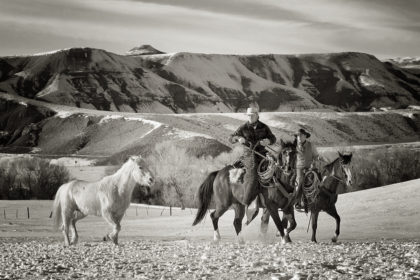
[229,120,276,154]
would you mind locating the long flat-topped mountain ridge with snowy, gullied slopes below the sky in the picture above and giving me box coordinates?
[0,45,420,113]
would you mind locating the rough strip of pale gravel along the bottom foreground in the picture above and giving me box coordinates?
[0,238,420,279]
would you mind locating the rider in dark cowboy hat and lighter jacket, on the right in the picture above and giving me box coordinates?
[293,128,319,209]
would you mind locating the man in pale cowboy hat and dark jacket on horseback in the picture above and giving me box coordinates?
[229,108,276,223]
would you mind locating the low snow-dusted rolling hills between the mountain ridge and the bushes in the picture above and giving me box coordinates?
[0,94,420,161]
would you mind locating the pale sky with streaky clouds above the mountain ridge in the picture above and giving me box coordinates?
[0,0,420,58]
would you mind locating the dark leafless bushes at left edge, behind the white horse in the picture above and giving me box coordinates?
[0,157,70,199]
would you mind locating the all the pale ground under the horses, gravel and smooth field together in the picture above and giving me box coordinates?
[0,180,420,279]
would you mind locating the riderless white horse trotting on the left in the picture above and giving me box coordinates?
[53,156,153,246]
